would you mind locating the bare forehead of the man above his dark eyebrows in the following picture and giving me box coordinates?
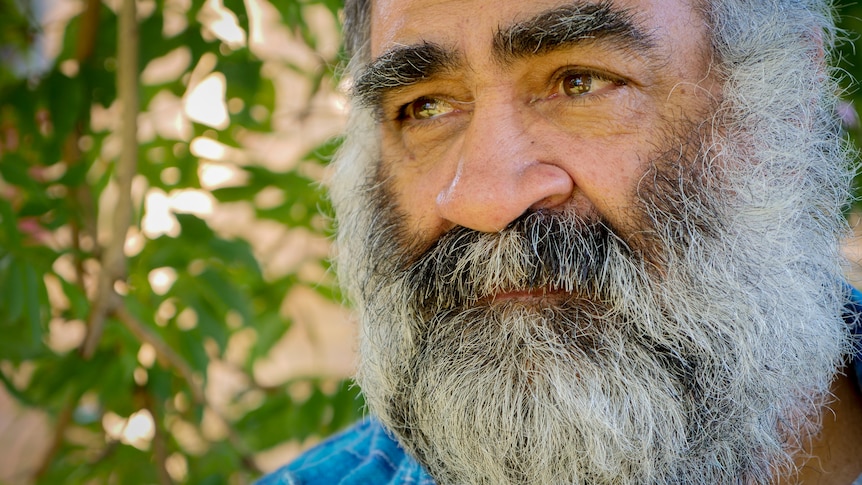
[371,0,706,58]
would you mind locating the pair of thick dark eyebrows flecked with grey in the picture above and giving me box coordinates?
[352,0,653,110]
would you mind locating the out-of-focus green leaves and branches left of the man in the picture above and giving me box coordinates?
[0,0,362,484]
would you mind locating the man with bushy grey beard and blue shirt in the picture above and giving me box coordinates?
[263,0,862,484]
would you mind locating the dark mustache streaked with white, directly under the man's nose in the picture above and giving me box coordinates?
[403,210,630,317]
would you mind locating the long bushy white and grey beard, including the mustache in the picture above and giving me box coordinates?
[333,6,850,484]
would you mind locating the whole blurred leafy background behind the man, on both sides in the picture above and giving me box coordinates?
[0,0,862,485]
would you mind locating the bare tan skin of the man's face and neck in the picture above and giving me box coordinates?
[371,0,862,484]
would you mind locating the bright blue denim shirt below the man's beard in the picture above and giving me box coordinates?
[256,288,862,485]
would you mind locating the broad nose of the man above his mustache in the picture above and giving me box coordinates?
[436,106,575,232]
